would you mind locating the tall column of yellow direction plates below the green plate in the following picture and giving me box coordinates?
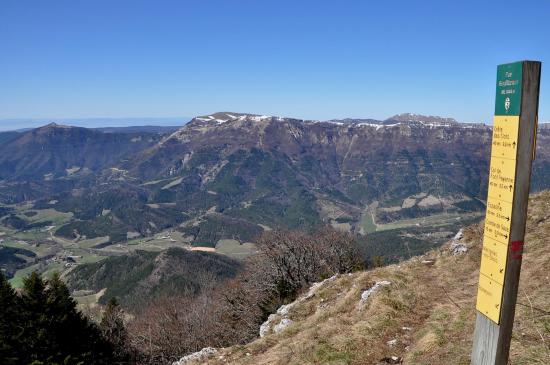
[476,116,519,323]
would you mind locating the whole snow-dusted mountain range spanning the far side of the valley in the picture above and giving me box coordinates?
[0,112,550,247]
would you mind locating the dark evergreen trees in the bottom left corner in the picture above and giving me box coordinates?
[0,272,131,365]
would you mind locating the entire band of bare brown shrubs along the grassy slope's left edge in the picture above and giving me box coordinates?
[128,228,362,364]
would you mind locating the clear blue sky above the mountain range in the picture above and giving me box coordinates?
[0,0,550,129]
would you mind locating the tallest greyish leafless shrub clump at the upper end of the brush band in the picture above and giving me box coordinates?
[219,228,362,343]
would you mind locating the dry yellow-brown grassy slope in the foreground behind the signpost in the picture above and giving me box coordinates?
[195,192,550,365]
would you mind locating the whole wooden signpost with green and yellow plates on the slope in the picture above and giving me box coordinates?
[471,61,541,365]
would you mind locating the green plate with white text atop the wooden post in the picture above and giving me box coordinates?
[495,62,523,115]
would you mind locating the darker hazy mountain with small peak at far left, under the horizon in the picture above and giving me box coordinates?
[0,123,165,181]
